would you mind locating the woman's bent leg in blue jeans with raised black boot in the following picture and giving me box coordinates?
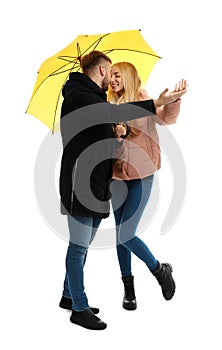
[112,175,176,300]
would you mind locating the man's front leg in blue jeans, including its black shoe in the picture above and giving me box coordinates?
[59,216,107,330]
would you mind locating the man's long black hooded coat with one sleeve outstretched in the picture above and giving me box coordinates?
[60,73,155,218]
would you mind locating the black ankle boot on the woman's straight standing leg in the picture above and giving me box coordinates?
[122,275,137,310]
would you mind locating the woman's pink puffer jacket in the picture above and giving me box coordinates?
[113,91,181,180]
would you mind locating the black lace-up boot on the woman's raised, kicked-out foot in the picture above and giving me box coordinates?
[151,263,176,300]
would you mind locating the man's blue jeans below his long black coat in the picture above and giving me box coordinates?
[63,216,101,311]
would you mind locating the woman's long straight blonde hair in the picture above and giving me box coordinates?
[107,62,144,136]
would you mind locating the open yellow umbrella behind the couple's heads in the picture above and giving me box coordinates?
[26,30,160,131]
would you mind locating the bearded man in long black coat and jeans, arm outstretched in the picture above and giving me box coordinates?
[60,51,185,330]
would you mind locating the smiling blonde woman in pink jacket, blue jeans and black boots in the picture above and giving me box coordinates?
[108,62,187,310]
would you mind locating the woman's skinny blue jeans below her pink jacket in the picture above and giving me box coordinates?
[111,175,158,276]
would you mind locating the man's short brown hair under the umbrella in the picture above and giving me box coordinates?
[79,51,112,74]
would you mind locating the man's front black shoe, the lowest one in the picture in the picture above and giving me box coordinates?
[70,308,107,330]
